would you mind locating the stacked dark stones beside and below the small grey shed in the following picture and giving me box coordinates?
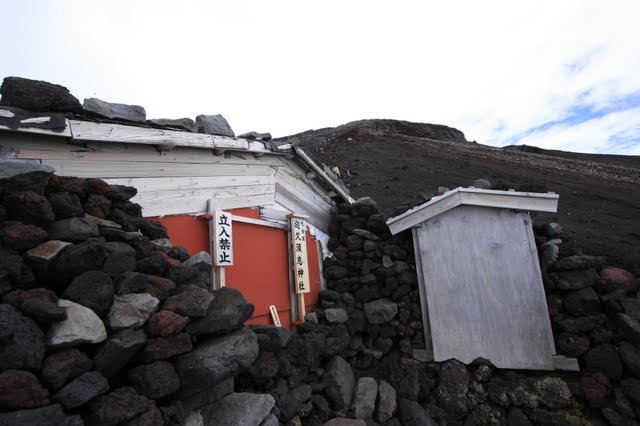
[232,199,640,425]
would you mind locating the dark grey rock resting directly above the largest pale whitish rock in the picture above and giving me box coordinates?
[63,271,114,318]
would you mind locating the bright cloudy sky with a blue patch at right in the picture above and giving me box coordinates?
[0,0,640,155]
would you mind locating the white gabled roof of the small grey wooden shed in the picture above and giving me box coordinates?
[387,188,558,235]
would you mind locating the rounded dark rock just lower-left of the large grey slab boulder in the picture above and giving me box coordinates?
[127,361,180,399]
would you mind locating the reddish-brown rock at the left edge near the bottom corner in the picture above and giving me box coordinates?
[0,370,49,410]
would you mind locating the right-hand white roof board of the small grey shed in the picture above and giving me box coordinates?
[460,190,558,212]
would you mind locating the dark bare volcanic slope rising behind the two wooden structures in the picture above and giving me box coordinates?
[276,120,640,275]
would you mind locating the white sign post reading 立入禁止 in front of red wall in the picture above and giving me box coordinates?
[209,200,233,289]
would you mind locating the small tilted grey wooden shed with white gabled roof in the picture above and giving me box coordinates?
[387,188,575,370]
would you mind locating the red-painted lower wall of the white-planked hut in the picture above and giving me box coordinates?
[153,208,321,327]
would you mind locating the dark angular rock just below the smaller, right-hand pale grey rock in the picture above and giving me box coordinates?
[93,328,147,377]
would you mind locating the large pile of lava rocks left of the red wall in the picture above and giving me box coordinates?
[0,161,274,426]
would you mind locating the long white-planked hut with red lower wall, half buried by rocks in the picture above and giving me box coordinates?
[0,106,353,327]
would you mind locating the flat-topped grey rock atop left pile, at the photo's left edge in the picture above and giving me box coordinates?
[0,160,54,195]
